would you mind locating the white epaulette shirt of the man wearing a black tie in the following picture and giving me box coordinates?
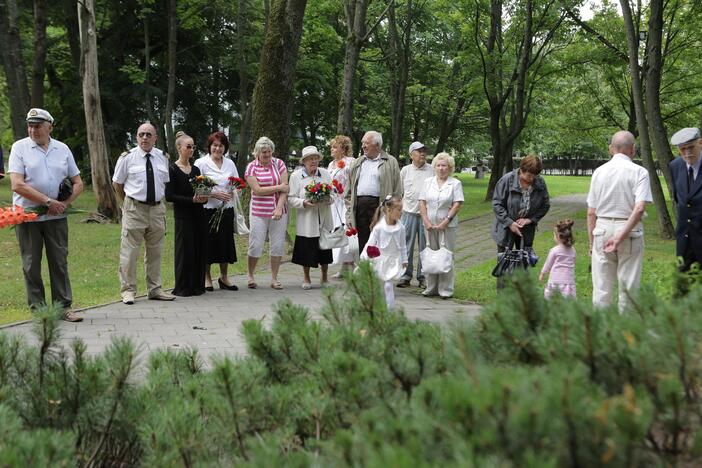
[112,146,170,202]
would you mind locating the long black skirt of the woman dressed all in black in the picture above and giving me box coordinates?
[173,213,207,296]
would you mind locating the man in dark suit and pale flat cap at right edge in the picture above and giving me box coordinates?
[669,128,702,271]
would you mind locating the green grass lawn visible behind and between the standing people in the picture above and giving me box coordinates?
[0,174,674,324]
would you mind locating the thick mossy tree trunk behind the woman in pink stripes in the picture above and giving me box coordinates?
[252,0,307,161]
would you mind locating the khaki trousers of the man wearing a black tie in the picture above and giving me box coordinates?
[119,197,166,294]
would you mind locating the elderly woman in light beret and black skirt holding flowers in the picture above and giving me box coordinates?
[288,146,334,290]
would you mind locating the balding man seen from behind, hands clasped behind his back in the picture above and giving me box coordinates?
[587,131,653,312]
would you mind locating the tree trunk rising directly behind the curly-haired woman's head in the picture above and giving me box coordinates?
[336,0,369,136]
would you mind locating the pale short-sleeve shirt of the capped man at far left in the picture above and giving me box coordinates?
[7,137,80,220]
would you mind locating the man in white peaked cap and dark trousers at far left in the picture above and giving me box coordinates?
[7,109,83,322]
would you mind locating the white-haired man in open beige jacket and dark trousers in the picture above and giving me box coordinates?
[346,130,402,252]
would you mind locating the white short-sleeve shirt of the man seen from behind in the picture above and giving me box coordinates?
[587,154,653,219]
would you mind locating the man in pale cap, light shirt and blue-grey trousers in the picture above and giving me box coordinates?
[397,141,434,288]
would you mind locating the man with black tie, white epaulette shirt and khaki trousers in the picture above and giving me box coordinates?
[112,123,175,304]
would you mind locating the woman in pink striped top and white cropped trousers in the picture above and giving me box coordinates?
[244,137,289,289]
